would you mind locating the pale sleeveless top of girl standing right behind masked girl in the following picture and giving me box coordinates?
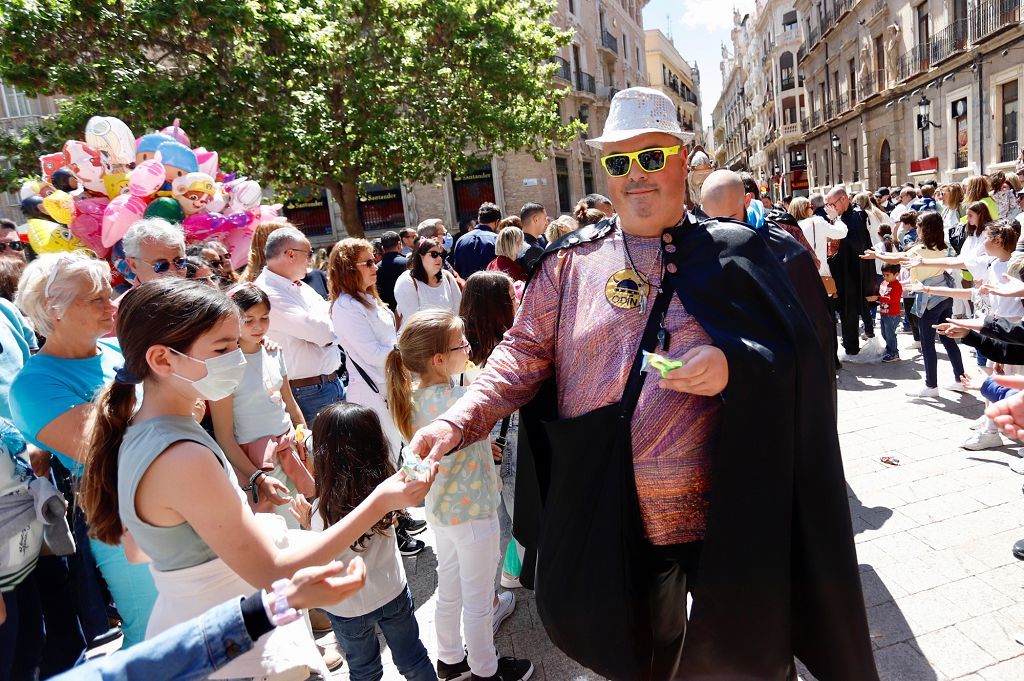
[231,347,292,444]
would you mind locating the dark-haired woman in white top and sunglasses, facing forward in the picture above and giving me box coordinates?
[393,239,462,327]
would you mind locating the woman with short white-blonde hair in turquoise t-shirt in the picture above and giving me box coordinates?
[10,252,157,647]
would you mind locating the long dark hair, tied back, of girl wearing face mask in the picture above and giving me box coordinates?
[82,278,239,544]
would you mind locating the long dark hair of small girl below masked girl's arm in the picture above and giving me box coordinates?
[313,402,398,552]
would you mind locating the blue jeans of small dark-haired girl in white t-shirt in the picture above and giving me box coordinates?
[327,578,437,681]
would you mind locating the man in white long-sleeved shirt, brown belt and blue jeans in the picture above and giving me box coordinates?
[256,227,345,424]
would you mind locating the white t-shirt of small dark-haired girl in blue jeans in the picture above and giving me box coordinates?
[309,500,406,618]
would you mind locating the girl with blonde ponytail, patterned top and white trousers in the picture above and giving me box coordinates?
[385,309,532,679]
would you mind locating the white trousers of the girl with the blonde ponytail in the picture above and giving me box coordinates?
[433,514,500,677]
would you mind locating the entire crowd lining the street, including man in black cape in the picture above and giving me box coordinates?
[8,88,1024,681]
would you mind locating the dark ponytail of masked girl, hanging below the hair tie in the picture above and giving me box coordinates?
[81,381,135,545]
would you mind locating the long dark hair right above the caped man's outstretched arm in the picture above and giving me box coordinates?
[459,271,515,367]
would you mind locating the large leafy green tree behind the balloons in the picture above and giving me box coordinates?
[0,0,578,235]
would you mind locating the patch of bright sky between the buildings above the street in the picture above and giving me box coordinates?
[643,0,754,132]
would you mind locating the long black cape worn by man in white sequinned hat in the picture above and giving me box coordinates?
[514,219,879,681]
